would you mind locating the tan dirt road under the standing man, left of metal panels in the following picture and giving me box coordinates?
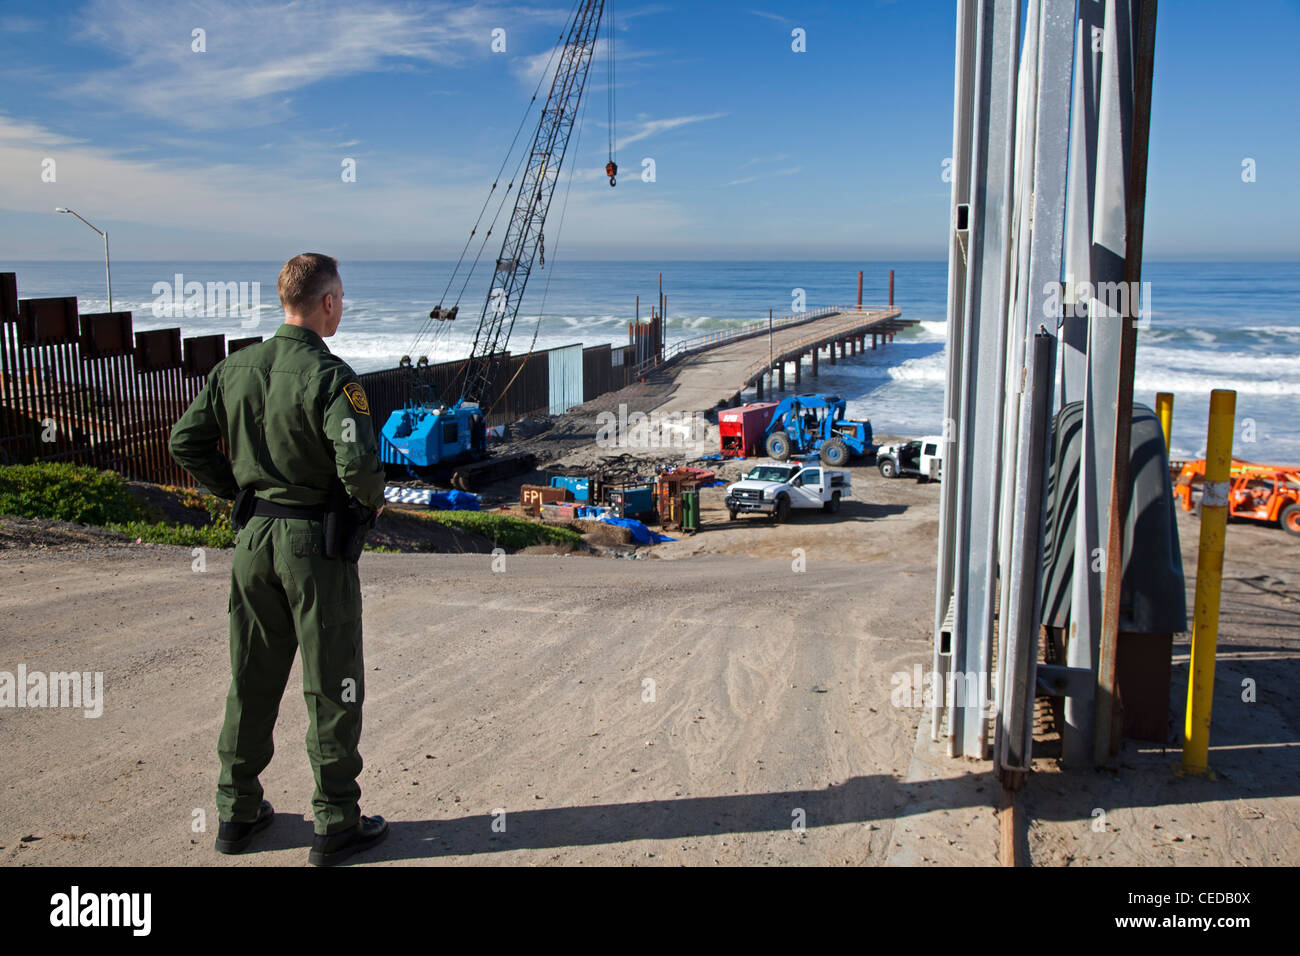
[0,473,995,865]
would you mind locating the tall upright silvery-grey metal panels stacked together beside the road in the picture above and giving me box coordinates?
[931,0,1154,770]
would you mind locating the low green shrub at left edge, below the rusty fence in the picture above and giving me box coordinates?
[0,462,147,524]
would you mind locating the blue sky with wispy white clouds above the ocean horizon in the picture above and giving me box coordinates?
[0,0,1300,260]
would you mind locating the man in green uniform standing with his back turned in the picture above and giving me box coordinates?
[170,252,387,865]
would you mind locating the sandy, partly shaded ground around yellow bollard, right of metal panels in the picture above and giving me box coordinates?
[1024,512,1300,866]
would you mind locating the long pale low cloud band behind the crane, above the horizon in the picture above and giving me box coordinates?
[0,113,698,259]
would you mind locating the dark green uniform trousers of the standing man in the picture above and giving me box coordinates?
[217,516,365,834]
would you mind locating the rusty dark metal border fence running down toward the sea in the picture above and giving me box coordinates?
[0,272,633,485]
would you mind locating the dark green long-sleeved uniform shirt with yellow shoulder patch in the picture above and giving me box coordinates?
[170,324,384,510]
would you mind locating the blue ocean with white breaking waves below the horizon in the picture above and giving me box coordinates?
[10,260,1300,463]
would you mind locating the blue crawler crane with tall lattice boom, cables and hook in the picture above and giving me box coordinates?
[380,0,618,490]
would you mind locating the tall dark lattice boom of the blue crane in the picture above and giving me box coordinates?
[460,0,605,402]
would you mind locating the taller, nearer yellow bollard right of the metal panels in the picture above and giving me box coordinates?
[1183,389,1236,774]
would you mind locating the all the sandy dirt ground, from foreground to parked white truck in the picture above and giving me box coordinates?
[0,467,1300,866]
